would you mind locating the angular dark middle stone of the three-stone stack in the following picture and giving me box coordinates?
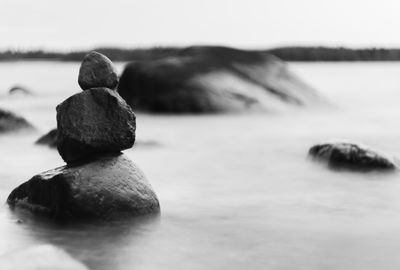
[57,88,136,163]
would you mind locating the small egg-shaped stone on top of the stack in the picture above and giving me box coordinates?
[78,51,118,90]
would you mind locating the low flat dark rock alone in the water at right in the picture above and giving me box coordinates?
[309,143,397,171]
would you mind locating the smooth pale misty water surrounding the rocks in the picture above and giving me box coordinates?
[0,62,400,270]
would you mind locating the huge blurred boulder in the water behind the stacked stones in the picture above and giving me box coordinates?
[118,47,318,113]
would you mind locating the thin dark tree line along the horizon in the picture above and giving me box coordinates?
[0,47,400,62]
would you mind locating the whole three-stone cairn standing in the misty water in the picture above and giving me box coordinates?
[7,52,160,219]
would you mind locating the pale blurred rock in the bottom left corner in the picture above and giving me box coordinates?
[0,245,88,270]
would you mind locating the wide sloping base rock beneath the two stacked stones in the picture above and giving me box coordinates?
[7,154,160,219]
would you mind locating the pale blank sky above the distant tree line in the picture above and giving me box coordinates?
[0,0,400,51]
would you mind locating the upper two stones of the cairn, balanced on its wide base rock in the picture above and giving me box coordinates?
[57,52,136,163]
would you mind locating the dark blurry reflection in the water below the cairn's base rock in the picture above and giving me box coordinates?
[8,210,160,269]
